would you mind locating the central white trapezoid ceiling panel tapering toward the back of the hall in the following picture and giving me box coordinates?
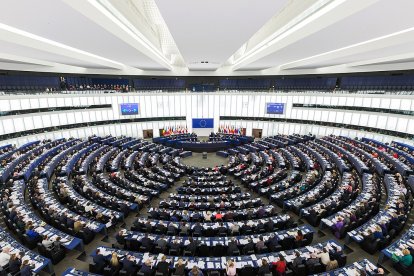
[155,0,287,69]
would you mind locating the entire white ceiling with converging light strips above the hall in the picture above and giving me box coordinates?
[0,0,414,76]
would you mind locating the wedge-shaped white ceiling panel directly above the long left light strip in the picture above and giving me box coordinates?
[0,0,167,69]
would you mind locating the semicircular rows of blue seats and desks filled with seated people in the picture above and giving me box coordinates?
[0,135,414,275]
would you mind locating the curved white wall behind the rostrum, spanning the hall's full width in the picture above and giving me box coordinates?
[0,92,414,146]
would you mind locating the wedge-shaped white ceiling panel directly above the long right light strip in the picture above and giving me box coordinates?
[244,0,414,70]
